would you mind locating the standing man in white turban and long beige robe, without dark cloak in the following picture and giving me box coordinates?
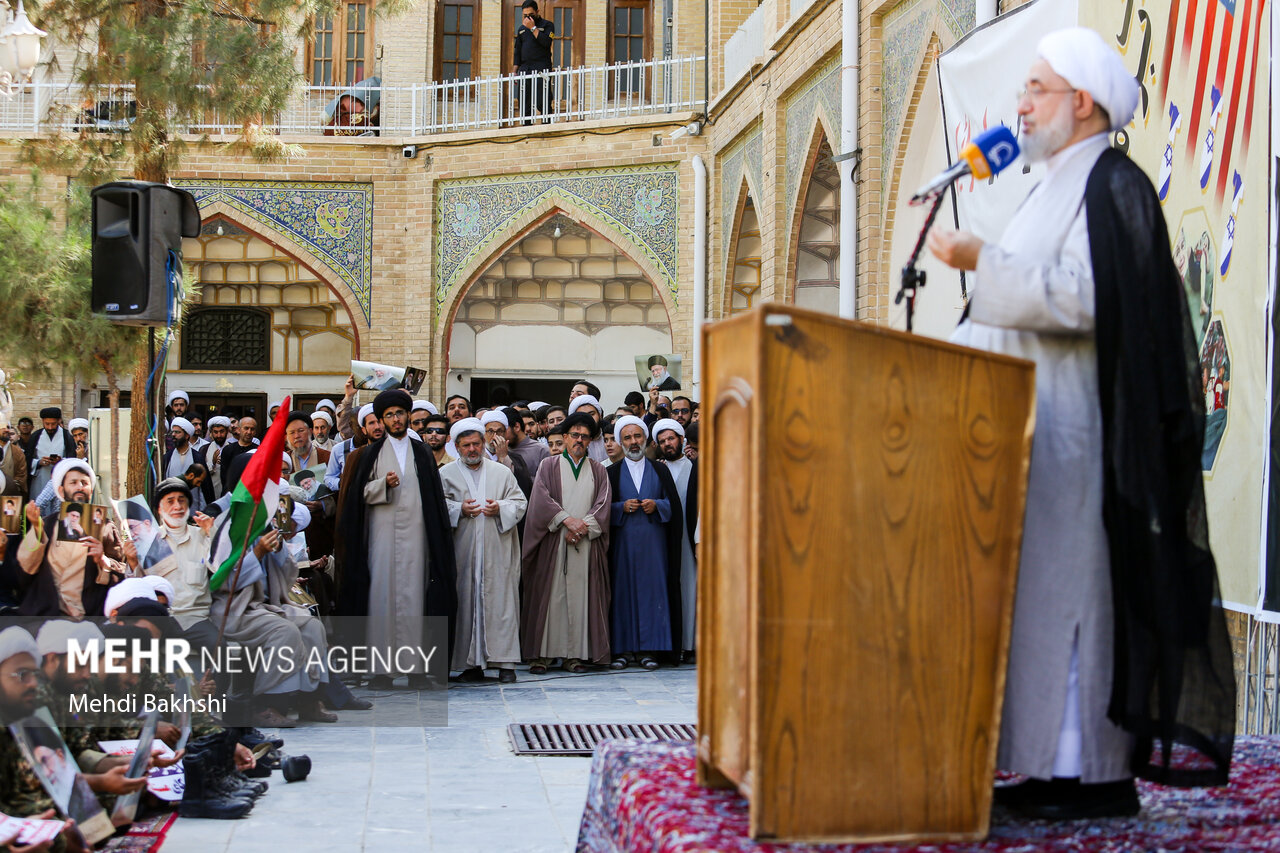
[440,418,527,684]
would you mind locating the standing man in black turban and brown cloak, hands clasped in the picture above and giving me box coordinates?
[520,414,612,675]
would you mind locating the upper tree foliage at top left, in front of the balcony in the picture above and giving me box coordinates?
[24,0,345,183]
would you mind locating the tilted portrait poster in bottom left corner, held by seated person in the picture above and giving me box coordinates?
[9,708,115,844]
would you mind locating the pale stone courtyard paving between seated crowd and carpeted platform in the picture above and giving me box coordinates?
[164,666,696,853]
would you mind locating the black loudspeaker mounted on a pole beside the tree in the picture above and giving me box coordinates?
[91,181,200,327]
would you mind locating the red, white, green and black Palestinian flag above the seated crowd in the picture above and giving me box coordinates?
[209,397,291,592]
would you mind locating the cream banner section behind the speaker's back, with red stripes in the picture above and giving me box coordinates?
[1080,0,1271,611]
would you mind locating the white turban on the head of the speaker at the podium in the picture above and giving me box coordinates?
[1036,27,1140,131]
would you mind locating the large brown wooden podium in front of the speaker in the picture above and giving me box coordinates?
[698,305,1036,841]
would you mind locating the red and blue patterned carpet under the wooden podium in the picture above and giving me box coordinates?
[577,738,1280,853]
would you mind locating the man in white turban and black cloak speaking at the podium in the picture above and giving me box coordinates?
[929,28,1235,820]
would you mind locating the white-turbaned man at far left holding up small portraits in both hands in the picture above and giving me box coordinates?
[18,459,132,620]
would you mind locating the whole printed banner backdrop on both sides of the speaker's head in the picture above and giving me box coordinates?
[940,0,1280,610]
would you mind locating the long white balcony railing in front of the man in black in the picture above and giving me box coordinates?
[0,56,705,137]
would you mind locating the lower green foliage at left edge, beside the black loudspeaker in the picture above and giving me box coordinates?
[0,175,146,375]
